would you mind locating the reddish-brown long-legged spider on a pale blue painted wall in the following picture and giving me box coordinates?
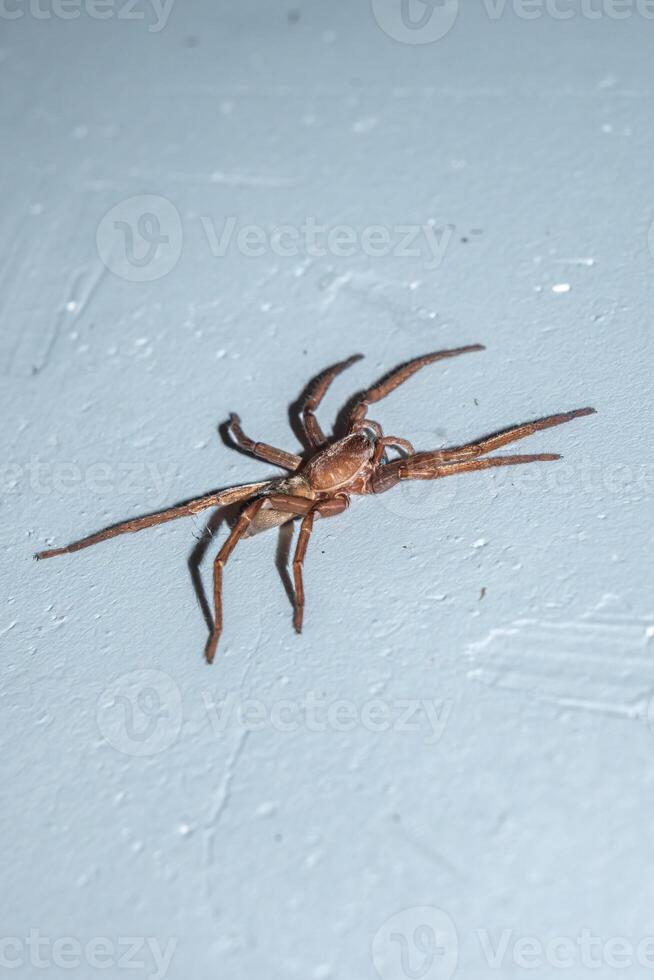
[35,344,595,663]
